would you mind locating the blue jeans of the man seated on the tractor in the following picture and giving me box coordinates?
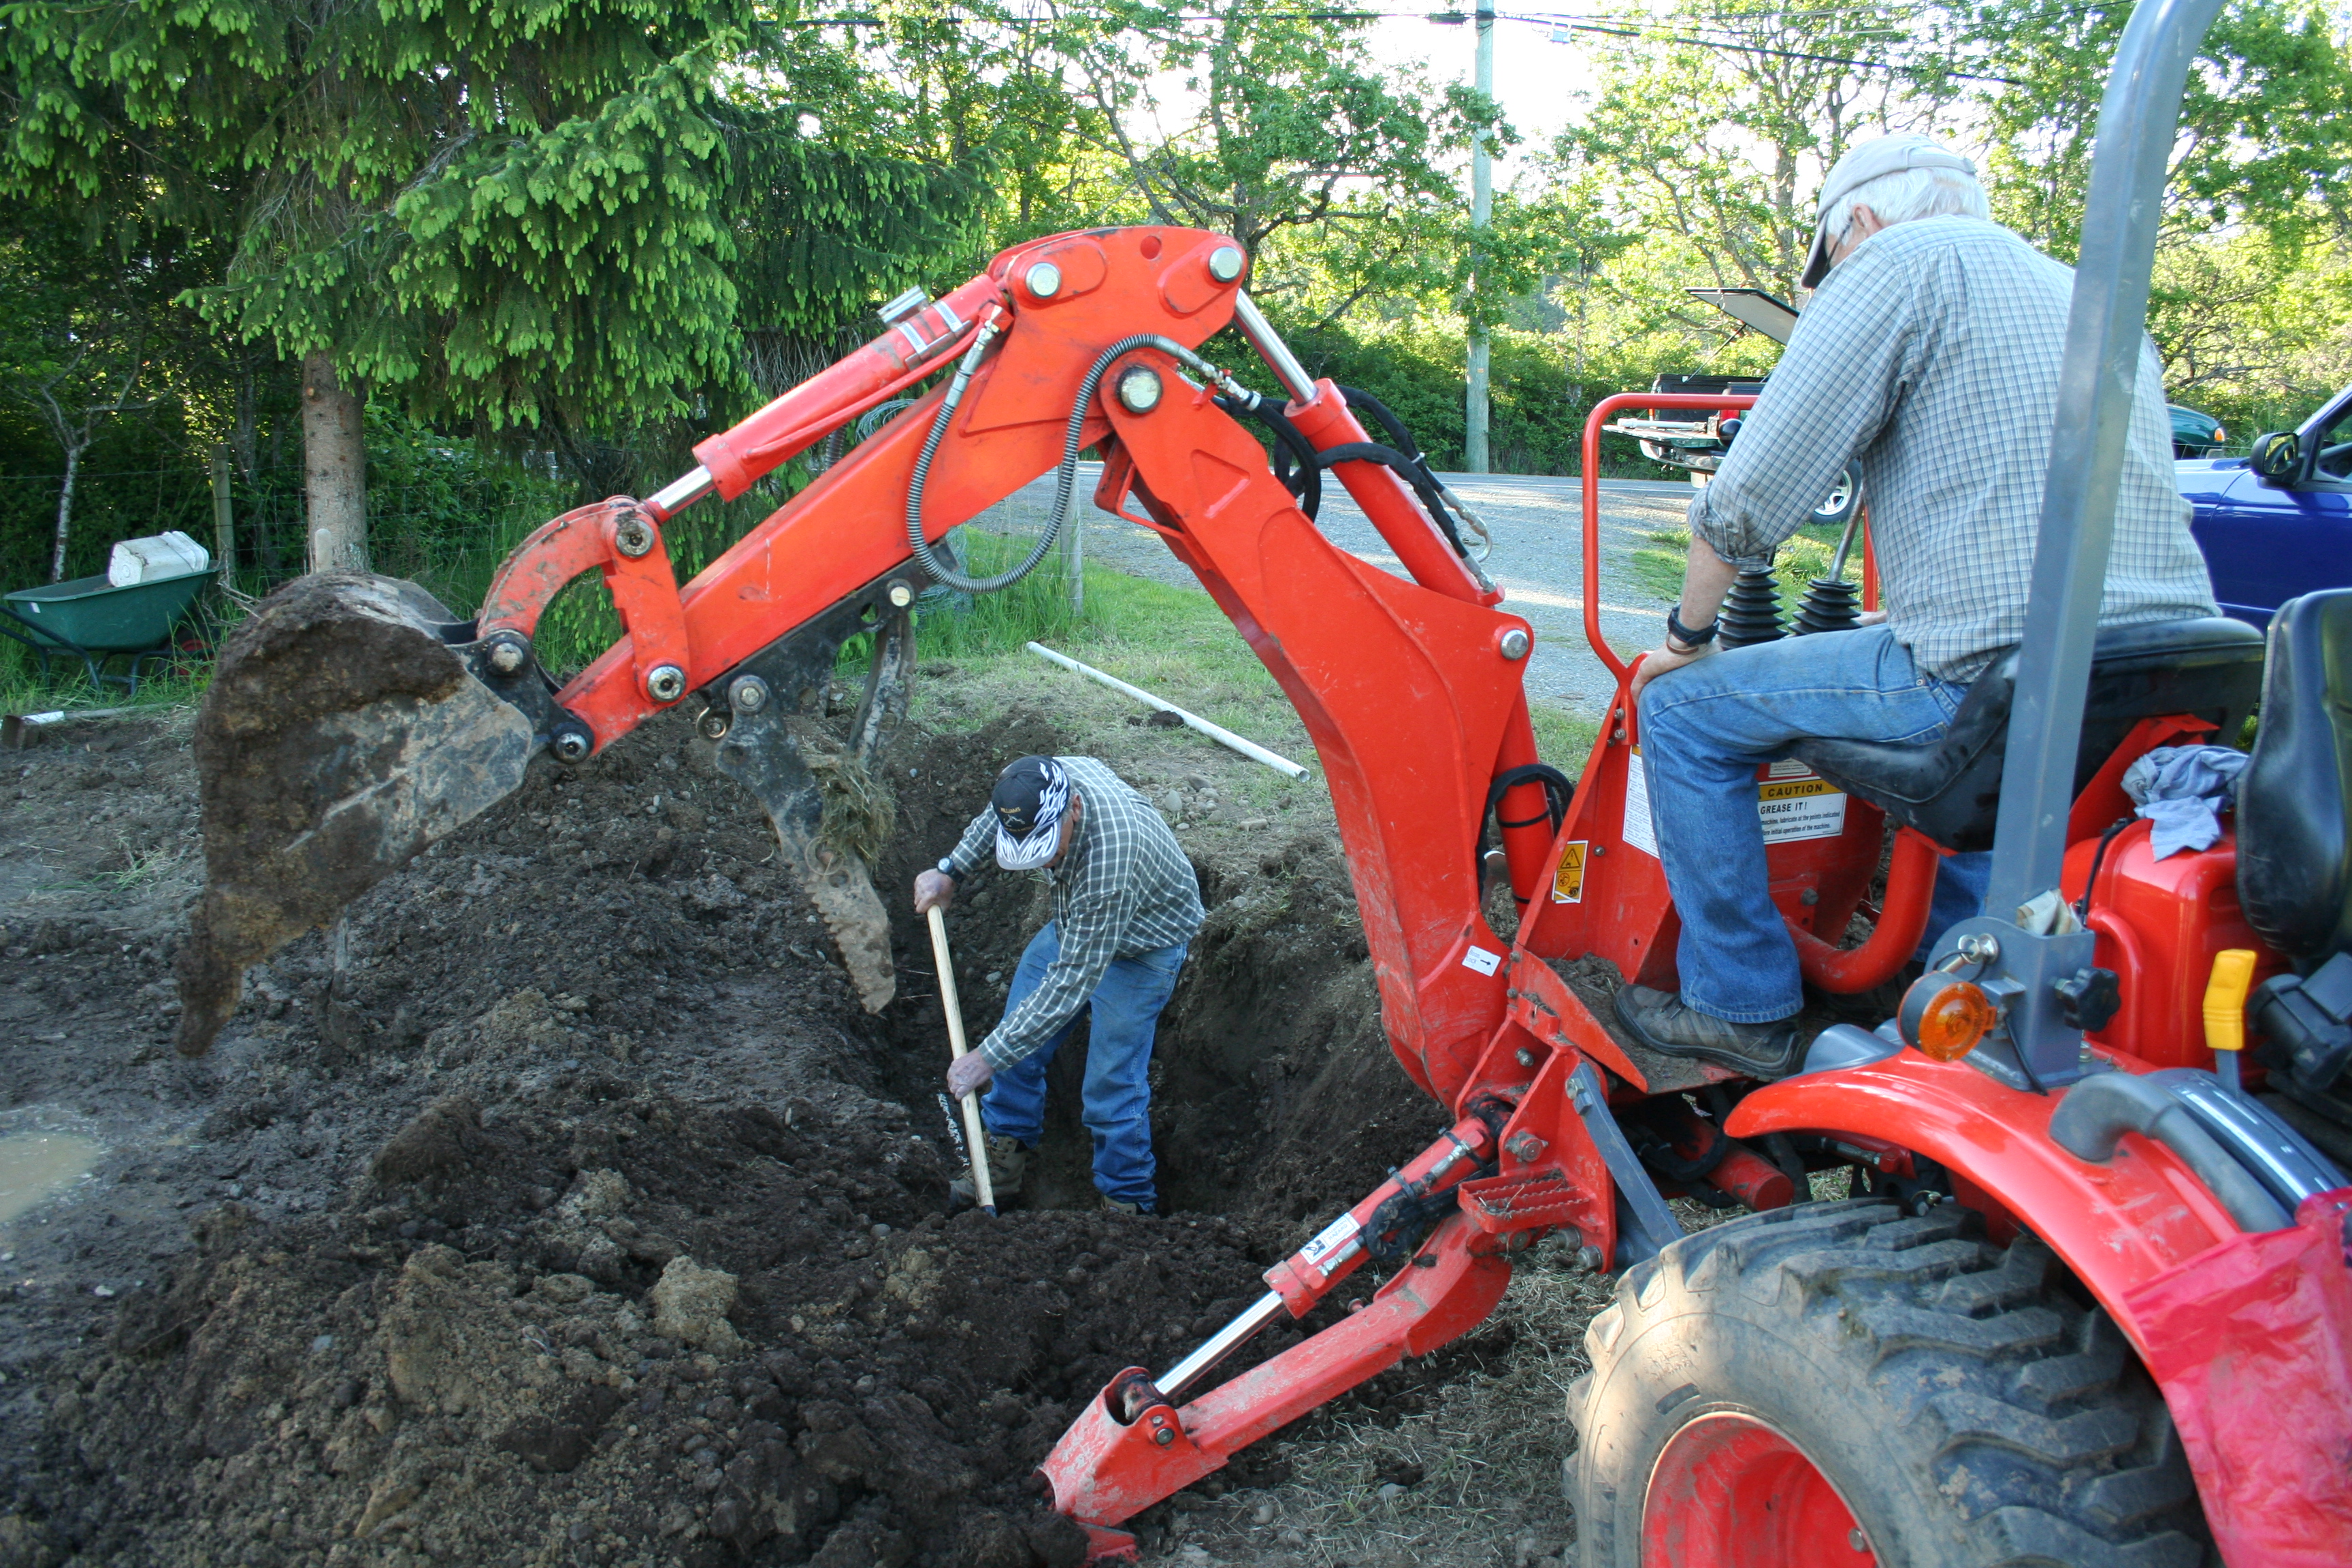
[1642,625,1992,1023]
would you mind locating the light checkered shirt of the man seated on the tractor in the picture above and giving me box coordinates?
[1691,216,2220,682]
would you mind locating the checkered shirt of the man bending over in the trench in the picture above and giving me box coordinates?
[945,757,1204,1067]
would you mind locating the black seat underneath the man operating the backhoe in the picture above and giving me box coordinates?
[1792,609,2267,860]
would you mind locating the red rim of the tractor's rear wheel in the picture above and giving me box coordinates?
[1642,1411,1879,1568]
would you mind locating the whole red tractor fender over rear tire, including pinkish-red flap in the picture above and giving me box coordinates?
[1724,1051,2352,1568]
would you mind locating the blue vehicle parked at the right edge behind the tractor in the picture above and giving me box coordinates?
[2173,388,2352,627]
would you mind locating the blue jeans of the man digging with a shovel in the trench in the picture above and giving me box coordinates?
[981,921,1186,1211]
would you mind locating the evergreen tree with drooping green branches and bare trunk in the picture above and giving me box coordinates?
[0,0,981,569]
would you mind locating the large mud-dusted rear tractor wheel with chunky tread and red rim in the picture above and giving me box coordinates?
[1569,1199,2208,1568]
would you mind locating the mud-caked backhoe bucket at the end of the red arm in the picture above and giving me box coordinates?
[174,571,536,1056]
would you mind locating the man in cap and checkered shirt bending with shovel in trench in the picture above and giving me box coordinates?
[915,757,1202,1213]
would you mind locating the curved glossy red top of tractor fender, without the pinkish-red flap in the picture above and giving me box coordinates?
[1724,1051,2239,1359]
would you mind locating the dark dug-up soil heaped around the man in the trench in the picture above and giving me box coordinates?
[0,715,1437,1568]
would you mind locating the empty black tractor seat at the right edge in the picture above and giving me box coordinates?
[2237,588,2352,959]
